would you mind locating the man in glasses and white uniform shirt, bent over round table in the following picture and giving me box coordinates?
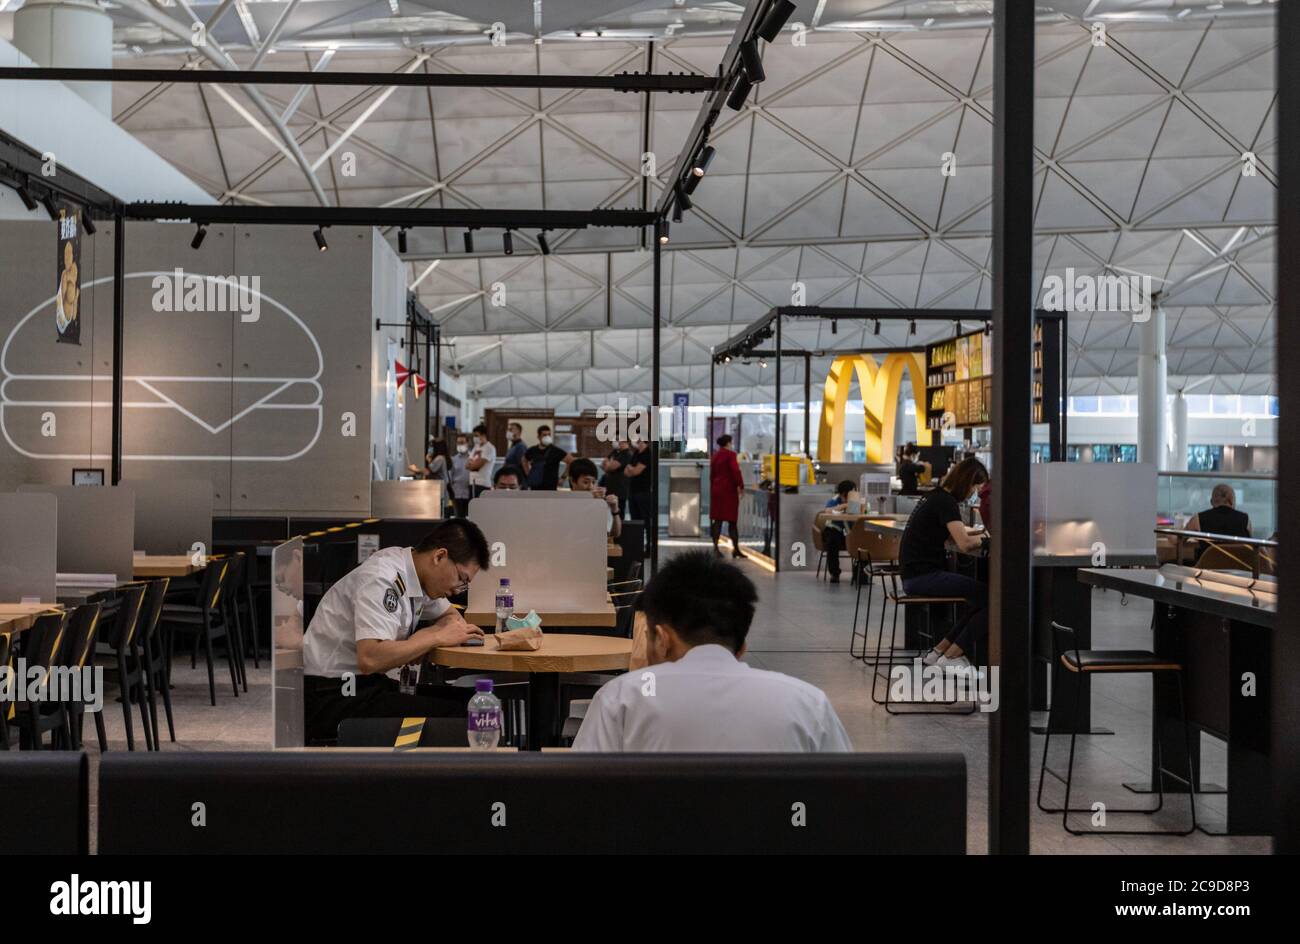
[303,518,488,740]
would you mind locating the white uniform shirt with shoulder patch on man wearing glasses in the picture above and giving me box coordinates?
[303,547,451,679]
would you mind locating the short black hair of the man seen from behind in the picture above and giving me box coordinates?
[641,550,758,653]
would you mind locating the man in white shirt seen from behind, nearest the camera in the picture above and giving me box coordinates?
[573,551,853,752]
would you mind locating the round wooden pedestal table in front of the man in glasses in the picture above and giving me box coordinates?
[429,633,632,750]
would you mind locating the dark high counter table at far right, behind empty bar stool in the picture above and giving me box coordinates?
[1079,564,1277,835]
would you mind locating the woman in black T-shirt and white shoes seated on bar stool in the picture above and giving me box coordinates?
[898,459,988,668]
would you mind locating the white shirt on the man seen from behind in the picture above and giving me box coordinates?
[573,645,853,753]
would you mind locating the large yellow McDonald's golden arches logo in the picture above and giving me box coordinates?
[818,352,930,462]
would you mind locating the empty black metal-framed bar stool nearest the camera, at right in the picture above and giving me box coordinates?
[1037,620,1196,836]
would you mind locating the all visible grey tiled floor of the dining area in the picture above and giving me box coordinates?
[71,547,1269,854]
